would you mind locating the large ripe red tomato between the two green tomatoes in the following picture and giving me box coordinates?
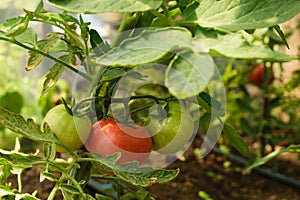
[85,118,152,163]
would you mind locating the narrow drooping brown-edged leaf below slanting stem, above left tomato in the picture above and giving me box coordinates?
[41,54,73,97]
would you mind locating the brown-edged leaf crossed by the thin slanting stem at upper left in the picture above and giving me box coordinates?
[25,36,60,71]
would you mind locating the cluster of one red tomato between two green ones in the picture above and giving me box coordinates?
[42,102,194,163]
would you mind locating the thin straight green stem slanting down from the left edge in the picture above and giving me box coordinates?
[0,36,93,81]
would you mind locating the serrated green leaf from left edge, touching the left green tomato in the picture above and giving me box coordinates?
[0,106,60,144]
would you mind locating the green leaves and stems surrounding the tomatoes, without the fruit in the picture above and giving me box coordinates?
[0,0,300,200]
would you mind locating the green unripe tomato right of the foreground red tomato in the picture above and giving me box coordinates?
[148,102,194,154]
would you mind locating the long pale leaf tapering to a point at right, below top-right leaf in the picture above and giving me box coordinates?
[194,31,295,61]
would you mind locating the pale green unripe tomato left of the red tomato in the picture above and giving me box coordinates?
[41,104,91,152]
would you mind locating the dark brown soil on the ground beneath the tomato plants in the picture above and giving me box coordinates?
[4,135,300,200]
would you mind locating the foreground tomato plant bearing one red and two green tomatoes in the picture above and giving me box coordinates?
[0,0,300,200]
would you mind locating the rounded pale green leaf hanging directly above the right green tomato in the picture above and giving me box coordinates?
[166,51,215,99]
